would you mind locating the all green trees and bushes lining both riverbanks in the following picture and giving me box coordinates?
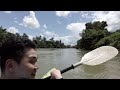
[0,21,120,50]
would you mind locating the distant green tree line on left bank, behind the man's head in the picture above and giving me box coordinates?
[0,26,71,48]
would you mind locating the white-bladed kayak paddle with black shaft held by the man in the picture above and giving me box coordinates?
[44,46,118,79]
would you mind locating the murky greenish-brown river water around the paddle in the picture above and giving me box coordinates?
[36,48,120,79]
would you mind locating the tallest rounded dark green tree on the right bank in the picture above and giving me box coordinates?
[77,21,109,50]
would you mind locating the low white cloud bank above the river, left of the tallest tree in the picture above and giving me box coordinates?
[44,23,85,45]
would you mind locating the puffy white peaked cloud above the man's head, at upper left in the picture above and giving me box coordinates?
[20,11,40,29]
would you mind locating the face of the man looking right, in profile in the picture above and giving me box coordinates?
[15,48,38,79]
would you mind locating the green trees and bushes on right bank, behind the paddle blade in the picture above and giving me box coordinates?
[77,21,120,50]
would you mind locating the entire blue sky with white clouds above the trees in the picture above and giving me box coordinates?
[0,11,120,45]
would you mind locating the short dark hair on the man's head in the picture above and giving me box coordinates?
[0,37,36,72]
